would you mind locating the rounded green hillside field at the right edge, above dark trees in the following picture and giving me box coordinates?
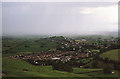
[100,49,120,61]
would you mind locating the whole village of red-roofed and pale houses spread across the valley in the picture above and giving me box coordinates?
[10,36,116,64]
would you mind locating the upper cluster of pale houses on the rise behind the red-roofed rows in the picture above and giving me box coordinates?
[58,39,111,53]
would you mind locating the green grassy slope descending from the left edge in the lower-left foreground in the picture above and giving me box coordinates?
[2,58,88,77]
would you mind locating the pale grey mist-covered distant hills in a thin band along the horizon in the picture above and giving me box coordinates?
[2,31,118,38]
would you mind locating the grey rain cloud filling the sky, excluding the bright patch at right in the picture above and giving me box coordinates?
[2,2,116,34]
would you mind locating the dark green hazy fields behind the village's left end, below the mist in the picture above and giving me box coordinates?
[2,38,56,56]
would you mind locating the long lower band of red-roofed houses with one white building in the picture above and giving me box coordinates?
[10,50,99,62]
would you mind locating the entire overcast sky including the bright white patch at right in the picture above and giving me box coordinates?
[2,2,118,35]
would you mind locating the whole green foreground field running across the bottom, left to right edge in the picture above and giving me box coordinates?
[2,57,118,77]
